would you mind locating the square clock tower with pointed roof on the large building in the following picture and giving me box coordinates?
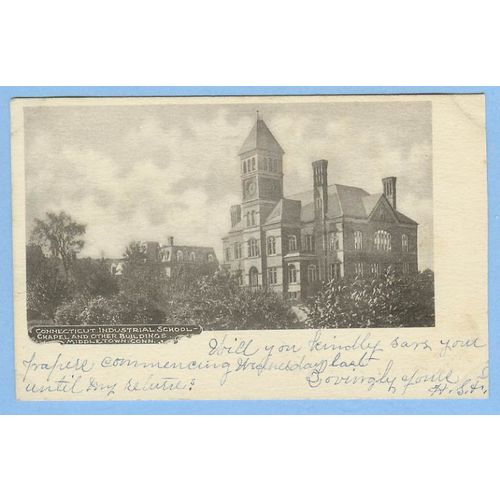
[239,115,285,227]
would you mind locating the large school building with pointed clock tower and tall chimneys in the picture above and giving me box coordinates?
[223,118,418,299]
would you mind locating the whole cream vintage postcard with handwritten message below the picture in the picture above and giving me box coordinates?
[11,94,488,400]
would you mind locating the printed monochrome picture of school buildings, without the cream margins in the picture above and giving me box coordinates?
[23,96,435,330]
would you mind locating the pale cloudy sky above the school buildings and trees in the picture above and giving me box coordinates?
[24,99,433,269]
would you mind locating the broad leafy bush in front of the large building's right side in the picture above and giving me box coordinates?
[306,270,435,328]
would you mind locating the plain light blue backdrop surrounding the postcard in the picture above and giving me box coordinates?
[0,87,500,414]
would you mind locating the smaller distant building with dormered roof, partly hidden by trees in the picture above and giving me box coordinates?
[111,236,219,278]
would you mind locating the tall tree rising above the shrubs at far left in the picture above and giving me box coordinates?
[31,212,86,277]
